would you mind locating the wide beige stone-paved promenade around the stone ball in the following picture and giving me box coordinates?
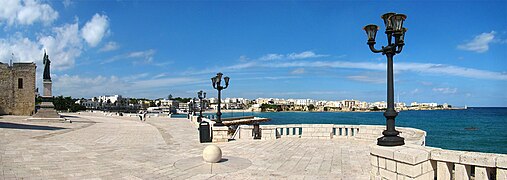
[0,113,371,179]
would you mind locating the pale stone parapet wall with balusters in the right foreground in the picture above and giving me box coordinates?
[370,144,507,180]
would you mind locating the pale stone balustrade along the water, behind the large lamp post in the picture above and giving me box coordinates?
[233,124,426,145]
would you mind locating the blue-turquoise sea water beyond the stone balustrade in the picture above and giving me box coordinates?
[215,108,507,154]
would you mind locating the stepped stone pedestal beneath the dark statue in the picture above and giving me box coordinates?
[27,79,65,122]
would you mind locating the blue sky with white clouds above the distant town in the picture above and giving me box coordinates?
[0,0,507,106]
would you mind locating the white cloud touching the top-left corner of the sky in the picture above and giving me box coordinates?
[0,0,58,26]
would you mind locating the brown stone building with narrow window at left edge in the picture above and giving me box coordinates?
[0,63,36,116]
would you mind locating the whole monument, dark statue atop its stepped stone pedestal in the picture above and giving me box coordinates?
[28,52,65,122]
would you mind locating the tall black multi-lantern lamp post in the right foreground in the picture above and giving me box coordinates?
[363,13,407,146]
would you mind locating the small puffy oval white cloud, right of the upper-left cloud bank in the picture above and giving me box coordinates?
[81,13,109,47]
